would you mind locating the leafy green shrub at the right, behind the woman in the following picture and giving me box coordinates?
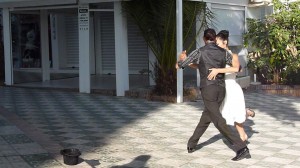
[244,0,300,84]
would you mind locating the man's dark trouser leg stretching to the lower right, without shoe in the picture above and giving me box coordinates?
[201,85,246,151]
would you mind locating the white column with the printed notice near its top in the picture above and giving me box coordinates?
[78,4,91,93]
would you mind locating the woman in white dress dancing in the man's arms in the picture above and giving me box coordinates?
[207,30,255,141]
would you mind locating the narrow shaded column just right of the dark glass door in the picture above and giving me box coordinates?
[40,10,50,81]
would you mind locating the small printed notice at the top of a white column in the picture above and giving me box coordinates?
[78,5,89,31]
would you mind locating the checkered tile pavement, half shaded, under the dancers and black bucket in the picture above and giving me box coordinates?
[0,87,300,168]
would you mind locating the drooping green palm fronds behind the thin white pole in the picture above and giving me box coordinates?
[122,0,213,94]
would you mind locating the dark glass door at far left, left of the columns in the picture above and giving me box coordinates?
[11,13,42,84]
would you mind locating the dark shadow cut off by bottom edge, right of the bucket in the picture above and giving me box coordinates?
[111,155,151,168]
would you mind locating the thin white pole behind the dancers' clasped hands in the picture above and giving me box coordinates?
[176,0,183,103]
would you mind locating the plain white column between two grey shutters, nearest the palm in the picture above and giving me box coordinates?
[114,2,129,96]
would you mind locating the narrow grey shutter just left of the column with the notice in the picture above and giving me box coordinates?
[65,15,79,67]
